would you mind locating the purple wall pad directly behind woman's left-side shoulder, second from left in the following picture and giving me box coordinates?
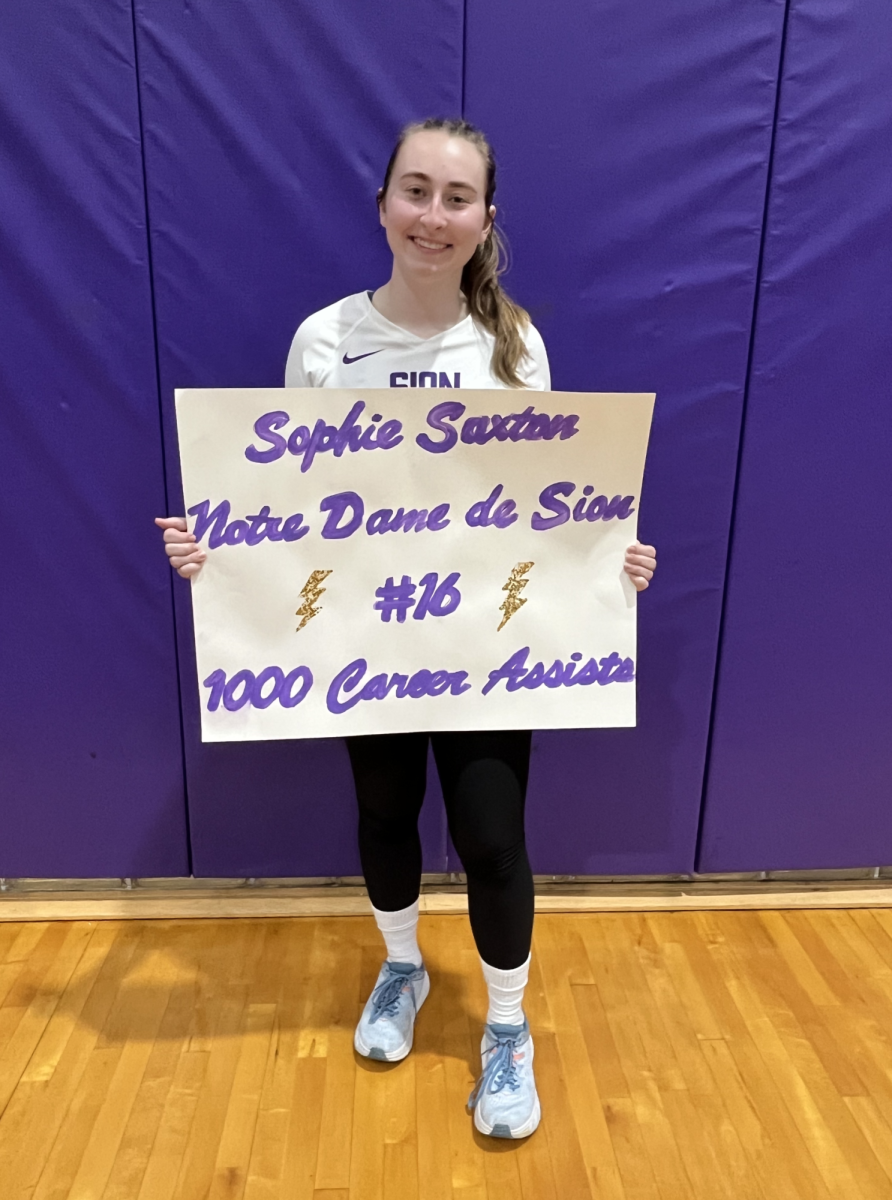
[136,0,462,876]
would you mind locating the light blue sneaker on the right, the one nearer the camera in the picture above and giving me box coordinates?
[468,1020,541,1138]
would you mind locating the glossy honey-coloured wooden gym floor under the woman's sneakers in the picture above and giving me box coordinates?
[0,910,892,1200]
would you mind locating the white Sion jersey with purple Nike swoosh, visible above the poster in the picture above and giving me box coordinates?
[285,292,551,391]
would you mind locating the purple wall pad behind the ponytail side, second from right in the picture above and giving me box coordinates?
[466,0,784,874]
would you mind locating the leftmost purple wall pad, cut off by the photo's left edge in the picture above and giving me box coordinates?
[0,7,188,876]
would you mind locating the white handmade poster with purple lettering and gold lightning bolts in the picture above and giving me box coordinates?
[176,389,654,742]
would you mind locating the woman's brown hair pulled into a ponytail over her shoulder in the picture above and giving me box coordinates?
[378,116,529,388]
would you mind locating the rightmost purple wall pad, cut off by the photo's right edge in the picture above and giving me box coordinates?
[700,0,892,871]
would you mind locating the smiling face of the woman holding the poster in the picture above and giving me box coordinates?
[378,130,496,287]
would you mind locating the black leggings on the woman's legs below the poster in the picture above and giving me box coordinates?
[347,730,533,971]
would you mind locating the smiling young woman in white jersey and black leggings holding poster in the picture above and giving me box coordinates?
[157,120,657,1138]
